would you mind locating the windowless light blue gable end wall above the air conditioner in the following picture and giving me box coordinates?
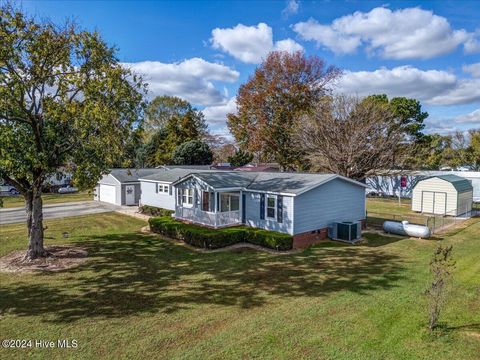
[293,179,365,234]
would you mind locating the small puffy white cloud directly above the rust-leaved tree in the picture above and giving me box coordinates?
[210,23,303,64]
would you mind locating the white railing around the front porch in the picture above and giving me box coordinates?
[175,206,241,227]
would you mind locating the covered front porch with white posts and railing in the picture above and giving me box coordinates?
[174,189,243,228]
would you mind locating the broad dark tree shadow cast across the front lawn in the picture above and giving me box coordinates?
[0,233,404,323]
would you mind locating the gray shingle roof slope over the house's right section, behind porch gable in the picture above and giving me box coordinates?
[172,171,366,195]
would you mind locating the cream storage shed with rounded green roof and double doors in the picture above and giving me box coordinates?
[412,175,473,216]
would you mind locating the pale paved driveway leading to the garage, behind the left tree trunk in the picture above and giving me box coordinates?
[0,201,120,225]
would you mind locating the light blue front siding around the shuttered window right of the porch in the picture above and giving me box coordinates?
[243,191,293,234]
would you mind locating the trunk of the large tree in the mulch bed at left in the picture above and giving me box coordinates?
[25,187,48,260]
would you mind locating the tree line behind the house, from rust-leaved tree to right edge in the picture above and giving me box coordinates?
[227,52,480,180]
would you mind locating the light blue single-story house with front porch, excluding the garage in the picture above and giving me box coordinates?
[140,169,366,247]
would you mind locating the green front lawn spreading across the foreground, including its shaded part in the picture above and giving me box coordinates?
[0,213,480,360]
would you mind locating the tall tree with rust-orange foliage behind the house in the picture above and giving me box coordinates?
[227,51,341,170]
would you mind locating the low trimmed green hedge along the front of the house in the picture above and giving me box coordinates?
[149,216,293,250]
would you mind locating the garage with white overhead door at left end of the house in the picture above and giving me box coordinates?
[94,169,162,205]
